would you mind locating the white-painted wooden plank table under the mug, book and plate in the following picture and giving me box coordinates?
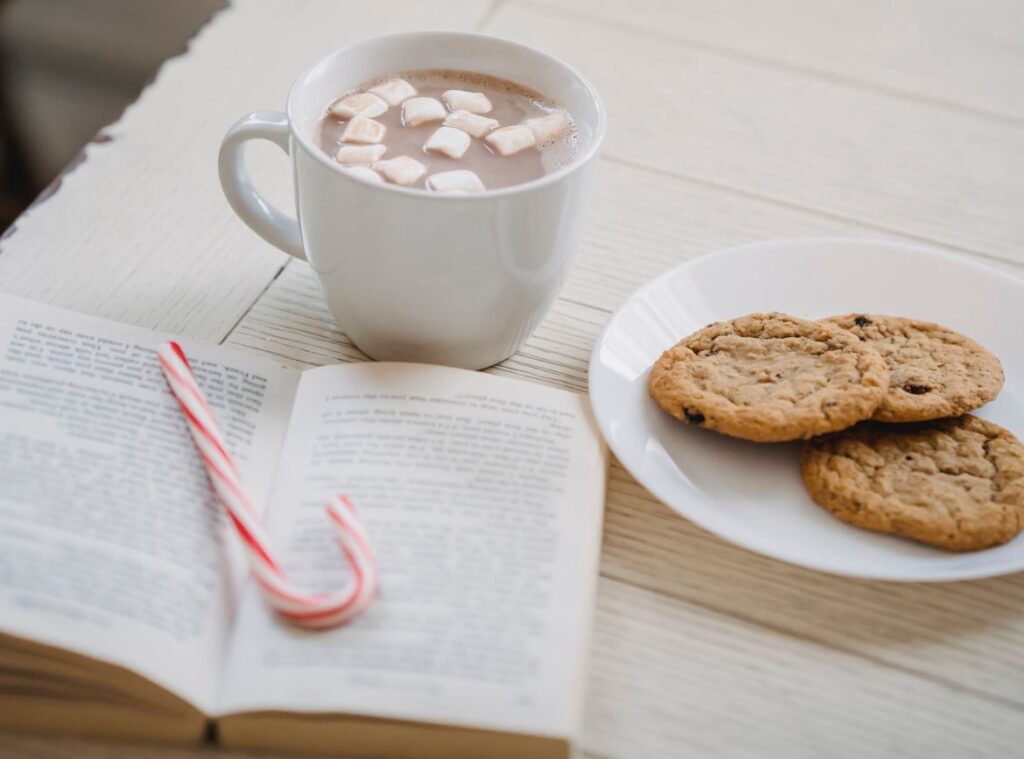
[0,0,1024,759]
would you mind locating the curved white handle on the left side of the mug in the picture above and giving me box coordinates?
[217,111,306,260]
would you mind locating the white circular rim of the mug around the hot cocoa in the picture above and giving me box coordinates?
[285,30,607,203]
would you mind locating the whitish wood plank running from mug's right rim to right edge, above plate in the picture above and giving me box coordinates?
[487,4,1024,261]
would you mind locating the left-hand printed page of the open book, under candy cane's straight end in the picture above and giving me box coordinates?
[0,296,300,711]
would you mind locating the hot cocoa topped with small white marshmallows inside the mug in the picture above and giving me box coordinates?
[316,71,578,194]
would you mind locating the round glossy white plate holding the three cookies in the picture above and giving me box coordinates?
[590,239,1024,582]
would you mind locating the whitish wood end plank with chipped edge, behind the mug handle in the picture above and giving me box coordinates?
[0,0,489,341]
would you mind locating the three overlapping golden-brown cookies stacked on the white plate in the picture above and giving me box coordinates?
[649,313,1024,551]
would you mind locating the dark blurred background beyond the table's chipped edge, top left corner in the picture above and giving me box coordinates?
[0,0,227,230]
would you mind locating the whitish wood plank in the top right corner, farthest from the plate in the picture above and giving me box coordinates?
[524,0,1024,121]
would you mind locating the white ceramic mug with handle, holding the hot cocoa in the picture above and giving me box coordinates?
[220,32,605,369]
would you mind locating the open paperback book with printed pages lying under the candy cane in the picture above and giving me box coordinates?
[0,296,607,757]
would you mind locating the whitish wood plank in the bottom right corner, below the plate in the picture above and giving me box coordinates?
[586,573,1024,759]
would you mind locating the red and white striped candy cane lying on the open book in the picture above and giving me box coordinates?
[157,340,377,629]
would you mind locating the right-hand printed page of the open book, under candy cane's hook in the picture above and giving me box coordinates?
[220,364,607,736]
